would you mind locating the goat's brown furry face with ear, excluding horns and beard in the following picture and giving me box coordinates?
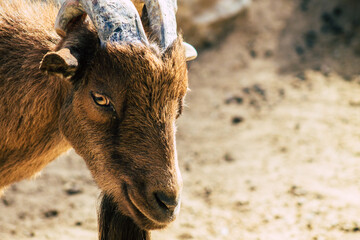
[42,31,187,230]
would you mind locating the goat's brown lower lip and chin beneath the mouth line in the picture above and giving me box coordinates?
[122,184,169,230]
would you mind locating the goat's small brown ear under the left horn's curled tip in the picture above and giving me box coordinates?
[40,48,78,78]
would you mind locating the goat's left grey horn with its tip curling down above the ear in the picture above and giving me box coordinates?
[55,0,148,44]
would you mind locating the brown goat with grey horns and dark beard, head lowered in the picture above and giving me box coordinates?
[0,0,196,240]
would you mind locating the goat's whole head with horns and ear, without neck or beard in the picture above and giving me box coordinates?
[40,0,196,230]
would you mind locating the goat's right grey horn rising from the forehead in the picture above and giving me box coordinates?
[143,0,177,50]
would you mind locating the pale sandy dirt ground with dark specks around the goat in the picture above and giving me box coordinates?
[0,0,360,240]
